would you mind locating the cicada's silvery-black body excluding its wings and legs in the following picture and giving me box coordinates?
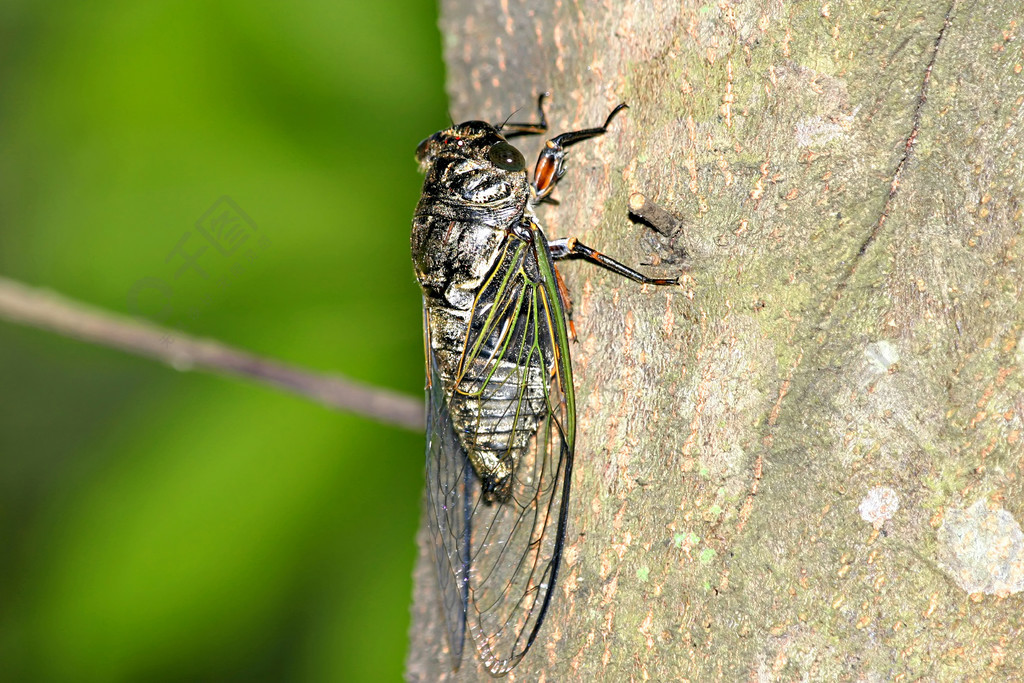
[412,129,550,504]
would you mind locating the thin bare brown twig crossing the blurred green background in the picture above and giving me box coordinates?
[0,278,423,430]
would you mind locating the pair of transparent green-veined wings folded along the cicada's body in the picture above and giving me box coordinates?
[427,223,575,675]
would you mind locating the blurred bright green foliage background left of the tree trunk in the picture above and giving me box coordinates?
[0,0,447,681]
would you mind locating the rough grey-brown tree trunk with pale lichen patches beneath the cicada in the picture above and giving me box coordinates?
[409,0,1024,681]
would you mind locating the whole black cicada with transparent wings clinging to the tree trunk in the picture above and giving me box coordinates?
[412,95,678,676]
